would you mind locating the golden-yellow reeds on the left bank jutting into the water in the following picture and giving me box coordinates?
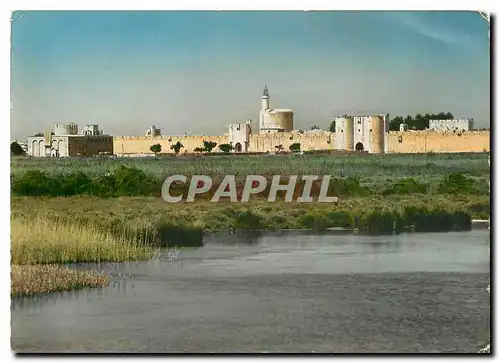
[11,216,153,296]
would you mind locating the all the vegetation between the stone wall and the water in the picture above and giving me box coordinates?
[11,154,490,295]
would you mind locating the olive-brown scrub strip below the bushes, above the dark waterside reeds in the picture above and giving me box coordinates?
[11,194,490,233]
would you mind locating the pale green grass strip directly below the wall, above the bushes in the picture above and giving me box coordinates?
[11,153,489,182]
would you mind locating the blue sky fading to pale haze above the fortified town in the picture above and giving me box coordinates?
[11,11,490,140]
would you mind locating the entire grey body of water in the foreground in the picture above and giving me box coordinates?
[11,230,489,353]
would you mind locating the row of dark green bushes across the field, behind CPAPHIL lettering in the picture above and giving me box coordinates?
[11,166,487,200]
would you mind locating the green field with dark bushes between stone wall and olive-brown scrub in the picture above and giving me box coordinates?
[11,154,490,197]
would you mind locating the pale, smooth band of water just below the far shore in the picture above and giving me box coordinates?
[49,230,489,286]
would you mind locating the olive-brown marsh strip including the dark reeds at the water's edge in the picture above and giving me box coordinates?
[12,195,474,237]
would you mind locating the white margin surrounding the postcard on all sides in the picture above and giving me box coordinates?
[0,0,500,361]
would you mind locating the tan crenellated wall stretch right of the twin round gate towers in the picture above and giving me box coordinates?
[388,131,490,153]
